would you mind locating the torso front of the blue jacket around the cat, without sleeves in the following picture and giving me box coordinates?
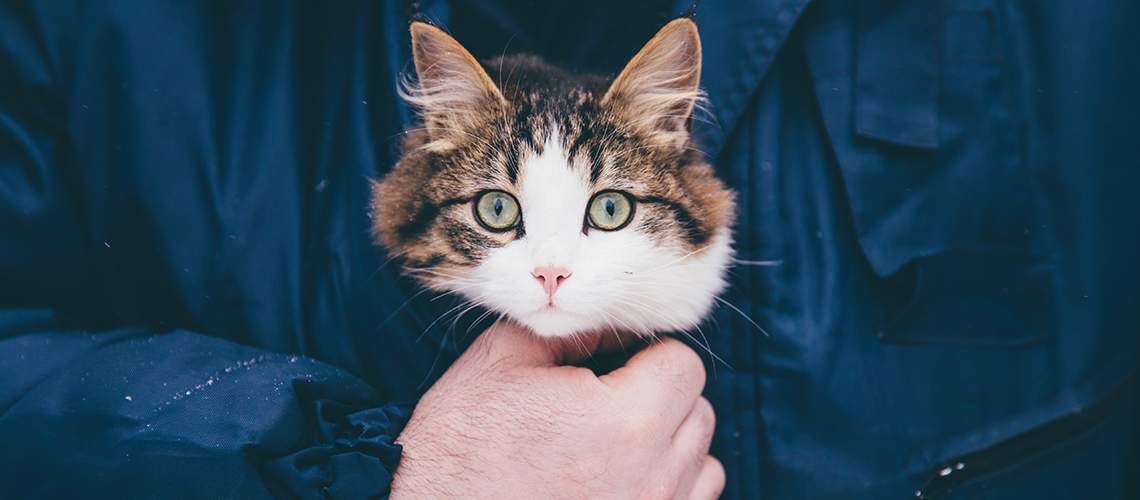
[31,1,1135,498]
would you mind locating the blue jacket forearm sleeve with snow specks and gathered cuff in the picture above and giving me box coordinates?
[0,310,409,498]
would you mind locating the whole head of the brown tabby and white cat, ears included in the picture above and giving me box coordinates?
[373,19,733,336]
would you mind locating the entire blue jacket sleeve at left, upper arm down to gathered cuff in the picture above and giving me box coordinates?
[0,2,409,498]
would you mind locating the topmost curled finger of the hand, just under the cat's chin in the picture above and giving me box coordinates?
[600,338,705,428]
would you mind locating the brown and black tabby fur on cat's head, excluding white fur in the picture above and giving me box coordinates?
[372,19,734,283]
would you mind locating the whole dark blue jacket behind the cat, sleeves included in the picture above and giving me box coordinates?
[0,0,1140,499]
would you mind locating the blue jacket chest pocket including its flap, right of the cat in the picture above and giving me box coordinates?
[805,0,1051,344]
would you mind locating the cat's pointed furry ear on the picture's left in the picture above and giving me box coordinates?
[401,21,506,145]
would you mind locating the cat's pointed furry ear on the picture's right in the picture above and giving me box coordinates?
[602,18,701,146]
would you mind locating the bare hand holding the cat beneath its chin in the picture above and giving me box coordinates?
[392,322,725,499]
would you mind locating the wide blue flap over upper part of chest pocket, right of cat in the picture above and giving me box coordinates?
[804,0,1040,277]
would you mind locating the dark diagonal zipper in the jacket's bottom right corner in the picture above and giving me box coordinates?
[914,375,1135,500]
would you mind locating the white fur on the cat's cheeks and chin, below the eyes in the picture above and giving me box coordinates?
[461,230,732,337]
